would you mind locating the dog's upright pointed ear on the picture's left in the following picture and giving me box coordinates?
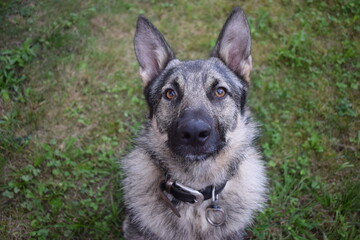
[134,16,175,86]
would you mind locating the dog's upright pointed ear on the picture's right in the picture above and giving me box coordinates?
[211,8,252,82]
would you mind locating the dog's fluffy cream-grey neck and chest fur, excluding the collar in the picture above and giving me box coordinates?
[122,110,266,240]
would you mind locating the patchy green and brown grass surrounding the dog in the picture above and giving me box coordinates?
[0,0,360,240]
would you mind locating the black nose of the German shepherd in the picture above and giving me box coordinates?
[177,119,211,146]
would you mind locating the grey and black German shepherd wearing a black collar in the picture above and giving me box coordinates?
[121,8,267,240]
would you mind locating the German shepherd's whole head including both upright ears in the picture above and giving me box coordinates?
[134,8,252,160]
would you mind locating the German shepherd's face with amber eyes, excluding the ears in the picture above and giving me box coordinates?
[146,58,247,160]
